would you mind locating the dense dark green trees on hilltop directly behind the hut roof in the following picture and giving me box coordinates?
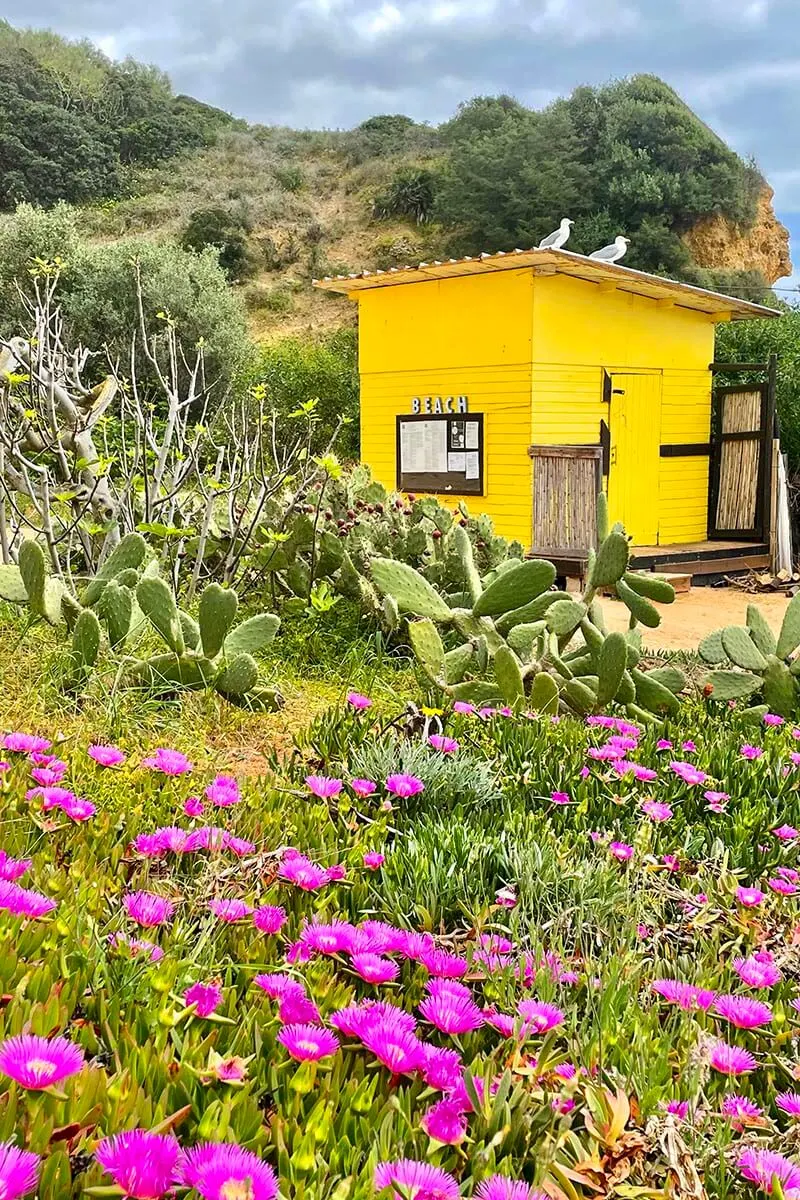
[434,76,762,277]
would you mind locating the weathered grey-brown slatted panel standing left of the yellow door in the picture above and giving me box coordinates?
[530,446,602,554]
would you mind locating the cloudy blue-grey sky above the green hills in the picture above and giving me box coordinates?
[2,0,800,283]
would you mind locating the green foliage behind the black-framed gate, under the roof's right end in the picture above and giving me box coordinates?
[716,306,800,472]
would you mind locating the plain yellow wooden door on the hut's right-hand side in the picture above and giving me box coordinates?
[608,372,661,546]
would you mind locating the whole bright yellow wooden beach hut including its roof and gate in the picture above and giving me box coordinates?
[317,250,780,574]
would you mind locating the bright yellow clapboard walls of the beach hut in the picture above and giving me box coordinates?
[359,269,714,546]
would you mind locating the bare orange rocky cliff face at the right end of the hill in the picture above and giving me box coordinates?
[684,186,792,283]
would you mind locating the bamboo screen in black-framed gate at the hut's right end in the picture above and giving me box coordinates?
[716,391,762,530]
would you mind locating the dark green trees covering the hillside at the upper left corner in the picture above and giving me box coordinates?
[0,22,231,209]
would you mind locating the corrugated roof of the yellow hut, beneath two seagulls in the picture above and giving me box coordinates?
[313,250,782,320]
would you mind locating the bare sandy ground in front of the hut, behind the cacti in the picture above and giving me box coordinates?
[601,588,789,650]
